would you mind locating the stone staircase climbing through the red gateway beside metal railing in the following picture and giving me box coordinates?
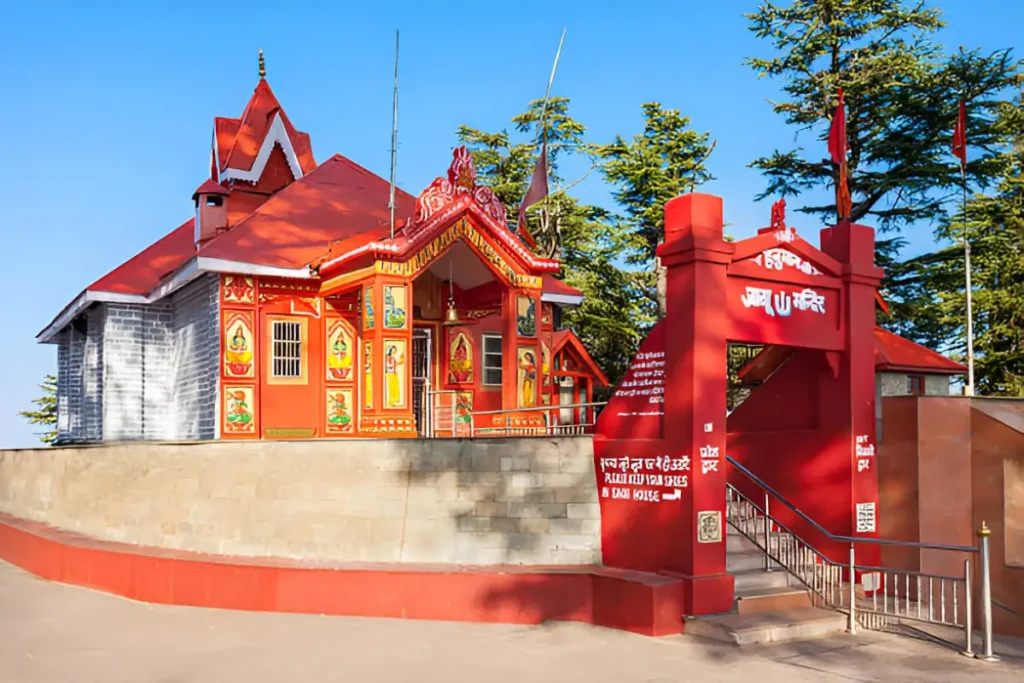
[686,525,846,645]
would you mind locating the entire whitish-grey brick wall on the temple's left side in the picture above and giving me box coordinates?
[50,274,220,442]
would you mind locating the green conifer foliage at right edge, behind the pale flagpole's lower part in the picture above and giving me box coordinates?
[886,90,1024,397]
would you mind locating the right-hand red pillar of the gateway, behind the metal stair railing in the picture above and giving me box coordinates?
[821,222,884,566]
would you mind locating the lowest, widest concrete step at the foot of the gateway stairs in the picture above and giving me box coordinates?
[684,607,846,645]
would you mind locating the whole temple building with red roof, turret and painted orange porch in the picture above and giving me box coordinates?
[38,57,607,443]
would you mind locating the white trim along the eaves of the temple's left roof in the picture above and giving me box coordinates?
[36,256,313,344]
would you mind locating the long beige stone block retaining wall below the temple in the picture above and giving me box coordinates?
[0,437,600,565]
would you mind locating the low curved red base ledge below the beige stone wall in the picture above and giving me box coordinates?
[0,515,683,636]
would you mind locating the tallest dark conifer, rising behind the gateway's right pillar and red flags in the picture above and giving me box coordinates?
[746,0,1017,237]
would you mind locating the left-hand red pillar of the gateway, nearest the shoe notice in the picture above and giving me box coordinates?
[658,194,734,614]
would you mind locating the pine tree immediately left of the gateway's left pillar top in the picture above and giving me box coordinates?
[596,102,715,317]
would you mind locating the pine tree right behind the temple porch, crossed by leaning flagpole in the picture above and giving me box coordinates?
[456,97,649,383]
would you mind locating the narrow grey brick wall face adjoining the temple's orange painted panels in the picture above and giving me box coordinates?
[171,273,220,439]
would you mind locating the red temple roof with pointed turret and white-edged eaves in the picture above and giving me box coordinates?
[39,79,583,341]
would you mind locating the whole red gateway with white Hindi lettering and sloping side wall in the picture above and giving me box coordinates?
[594,194,883,614]
